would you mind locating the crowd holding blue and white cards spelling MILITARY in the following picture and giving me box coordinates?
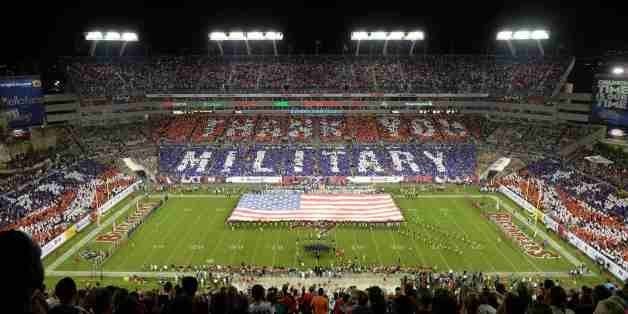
[159,144,475,182]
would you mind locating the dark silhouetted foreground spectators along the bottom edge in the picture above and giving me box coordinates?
[0,231,628,314]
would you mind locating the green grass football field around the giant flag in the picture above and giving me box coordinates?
[47,192,578,273]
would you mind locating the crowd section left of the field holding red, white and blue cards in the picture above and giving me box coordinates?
[0,155,135,246]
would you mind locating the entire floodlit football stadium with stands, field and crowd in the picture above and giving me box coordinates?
[0,3,628,314]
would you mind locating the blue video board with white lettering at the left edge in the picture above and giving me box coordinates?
[0,76,45,128]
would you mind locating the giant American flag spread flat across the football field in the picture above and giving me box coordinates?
[227,191,403,222]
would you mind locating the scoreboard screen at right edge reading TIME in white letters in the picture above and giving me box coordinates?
[591,75,628,126]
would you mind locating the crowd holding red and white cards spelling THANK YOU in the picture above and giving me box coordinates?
[150,114,591,155]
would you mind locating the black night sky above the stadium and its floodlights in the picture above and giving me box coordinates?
[0,0,628,92]
